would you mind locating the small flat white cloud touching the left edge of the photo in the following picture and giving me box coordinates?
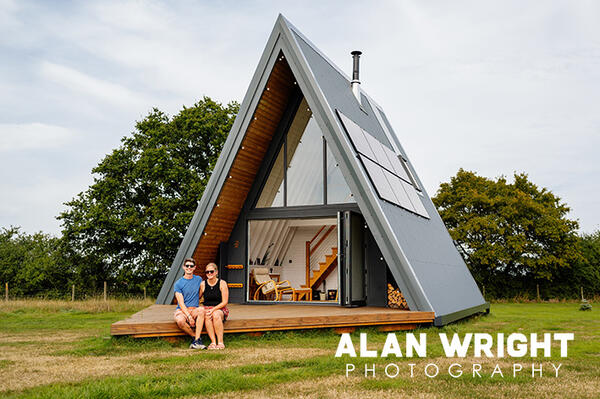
[0,123,75,152]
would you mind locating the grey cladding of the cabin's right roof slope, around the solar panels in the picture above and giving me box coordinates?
[291,18,486,317]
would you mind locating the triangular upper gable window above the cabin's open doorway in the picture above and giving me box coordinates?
[256,99,355,208]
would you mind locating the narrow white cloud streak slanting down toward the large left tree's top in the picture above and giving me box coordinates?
[40,61,148,109]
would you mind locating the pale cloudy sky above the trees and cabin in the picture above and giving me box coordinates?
[0,0,600,235]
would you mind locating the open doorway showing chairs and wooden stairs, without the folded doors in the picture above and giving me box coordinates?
[246,217,341,304]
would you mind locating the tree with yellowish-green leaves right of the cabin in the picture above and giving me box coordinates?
[432,169,581,296]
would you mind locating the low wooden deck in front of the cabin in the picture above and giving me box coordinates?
[110,304,434,338]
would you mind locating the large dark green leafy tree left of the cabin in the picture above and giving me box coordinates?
[58,97,238,293]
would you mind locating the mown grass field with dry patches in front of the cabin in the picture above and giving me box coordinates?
[0,300,600,399]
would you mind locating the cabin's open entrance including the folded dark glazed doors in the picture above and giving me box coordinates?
[246,211,367,307]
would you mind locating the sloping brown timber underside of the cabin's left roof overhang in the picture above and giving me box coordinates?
[193,54,295,276]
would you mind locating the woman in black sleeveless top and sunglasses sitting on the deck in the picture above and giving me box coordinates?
[200,263,229,349]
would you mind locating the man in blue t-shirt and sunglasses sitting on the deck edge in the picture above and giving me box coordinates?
[174,258,206,349]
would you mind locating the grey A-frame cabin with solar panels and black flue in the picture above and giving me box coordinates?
[113,15,489,338]
